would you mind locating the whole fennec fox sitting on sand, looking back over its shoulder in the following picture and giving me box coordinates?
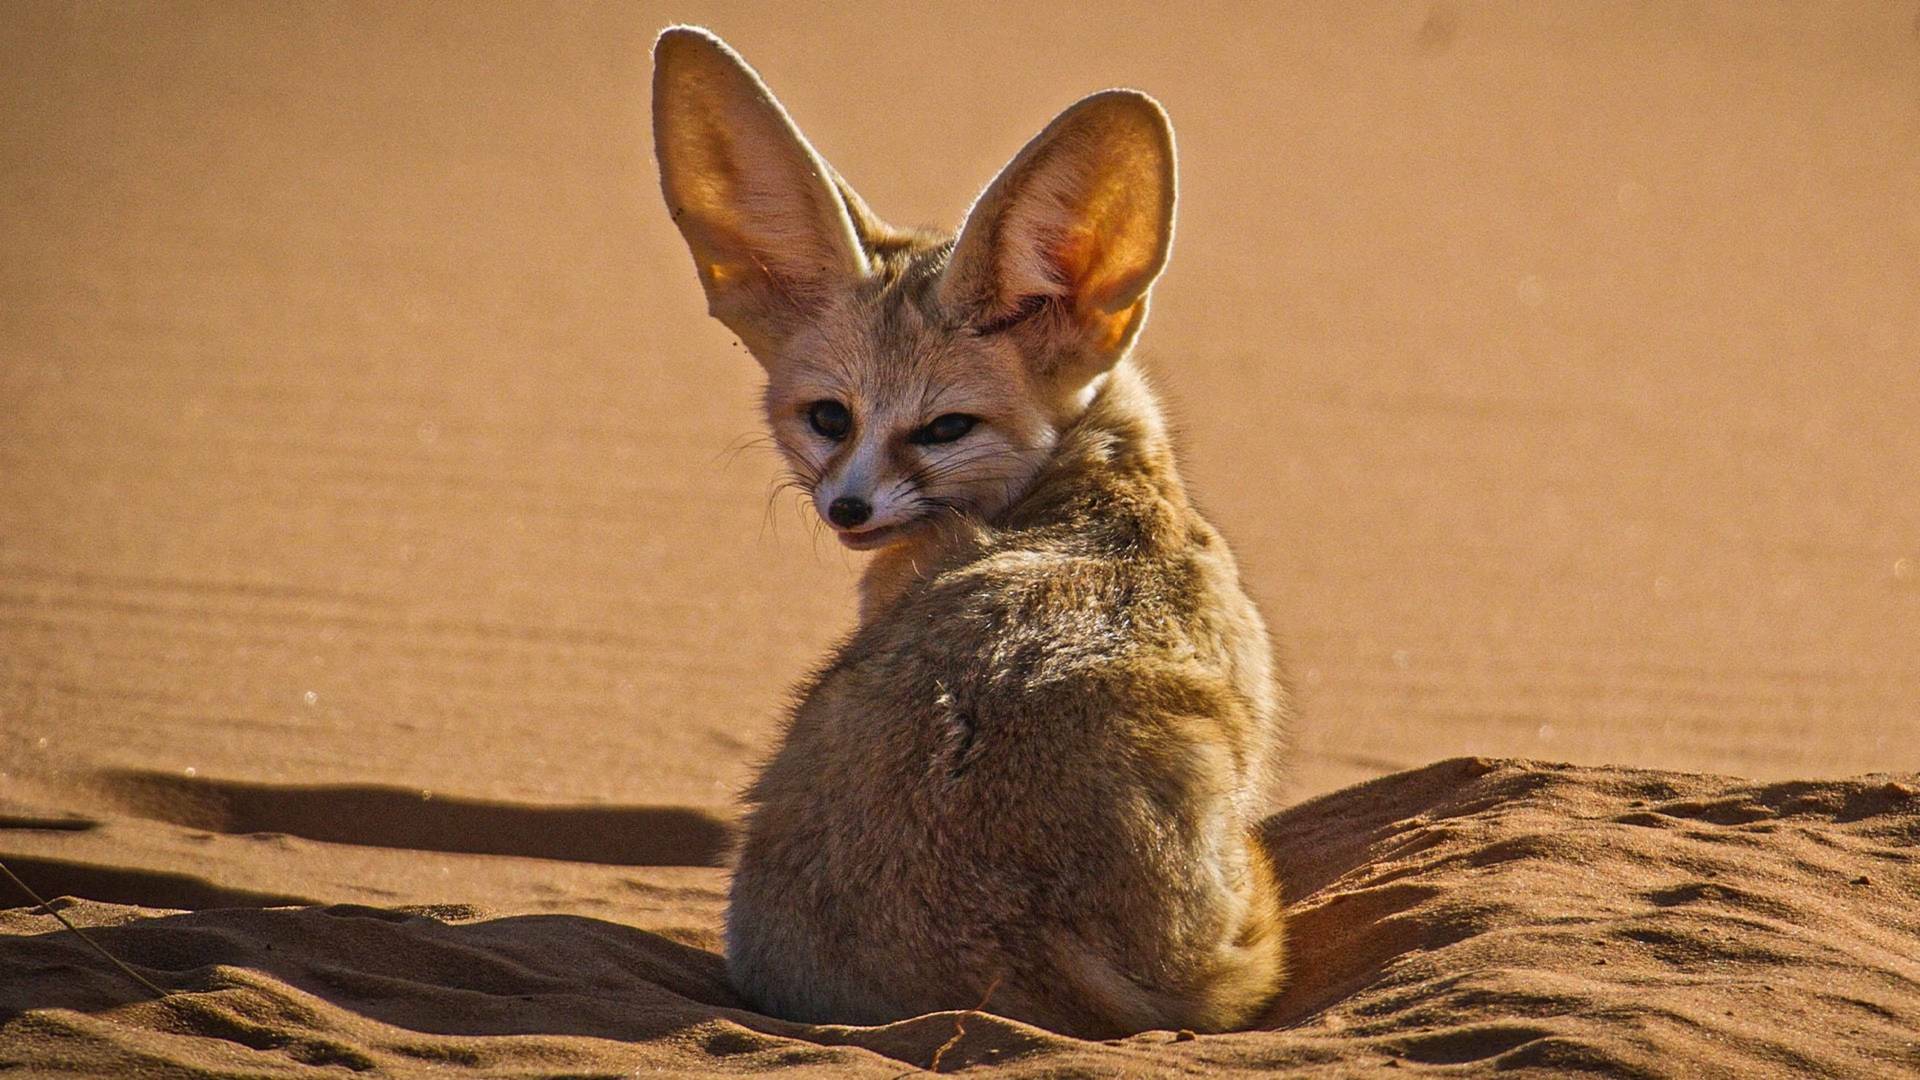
[653,27,1286,1038]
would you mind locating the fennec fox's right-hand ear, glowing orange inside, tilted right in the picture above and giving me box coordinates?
[941,90,1175,384]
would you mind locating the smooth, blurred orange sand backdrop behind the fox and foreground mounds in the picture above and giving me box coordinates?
[0,0,1920,1068]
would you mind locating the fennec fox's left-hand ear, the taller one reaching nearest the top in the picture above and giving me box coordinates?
[653,27,872,363]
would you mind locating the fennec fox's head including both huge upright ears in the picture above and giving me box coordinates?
[653,27,1175,550]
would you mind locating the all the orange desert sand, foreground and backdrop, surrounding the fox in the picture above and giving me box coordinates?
[0,2,1920,1076]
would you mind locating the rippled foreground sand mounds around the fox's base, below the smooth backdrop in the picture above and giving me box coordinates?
[0,759,1920,1076]
